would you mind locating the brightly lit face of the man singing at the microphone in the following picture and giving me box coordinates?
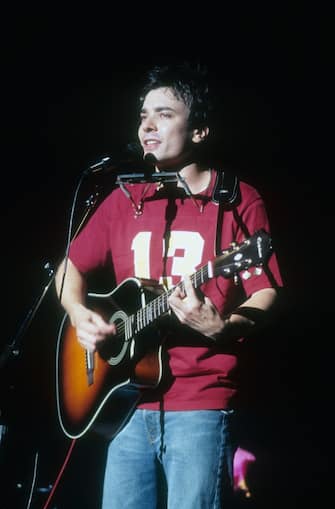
[138,88,193,168]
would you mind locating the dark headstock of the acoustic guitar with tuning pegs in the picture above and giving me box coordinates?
[214,230,272,278]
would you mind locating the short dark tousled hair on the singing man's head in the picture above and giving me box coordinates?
[140,61,211,129]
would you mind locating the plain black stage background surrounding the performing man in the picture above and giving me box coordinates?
[0,5,333,509]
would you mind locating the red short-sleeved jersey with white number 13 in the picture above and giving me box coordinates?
[70,171,282,410]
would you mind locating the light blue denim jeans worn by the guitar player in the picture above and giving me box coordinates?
[102,410,236,509]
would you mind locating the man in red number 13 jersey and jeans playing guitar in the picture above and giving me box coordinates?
[56,64,282,509]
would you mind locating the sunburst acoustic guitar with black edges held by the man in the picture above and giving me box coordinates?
[56,230,272,438]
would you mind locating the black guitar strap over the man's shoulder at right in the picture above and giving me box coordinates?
[212,170,240,256]
